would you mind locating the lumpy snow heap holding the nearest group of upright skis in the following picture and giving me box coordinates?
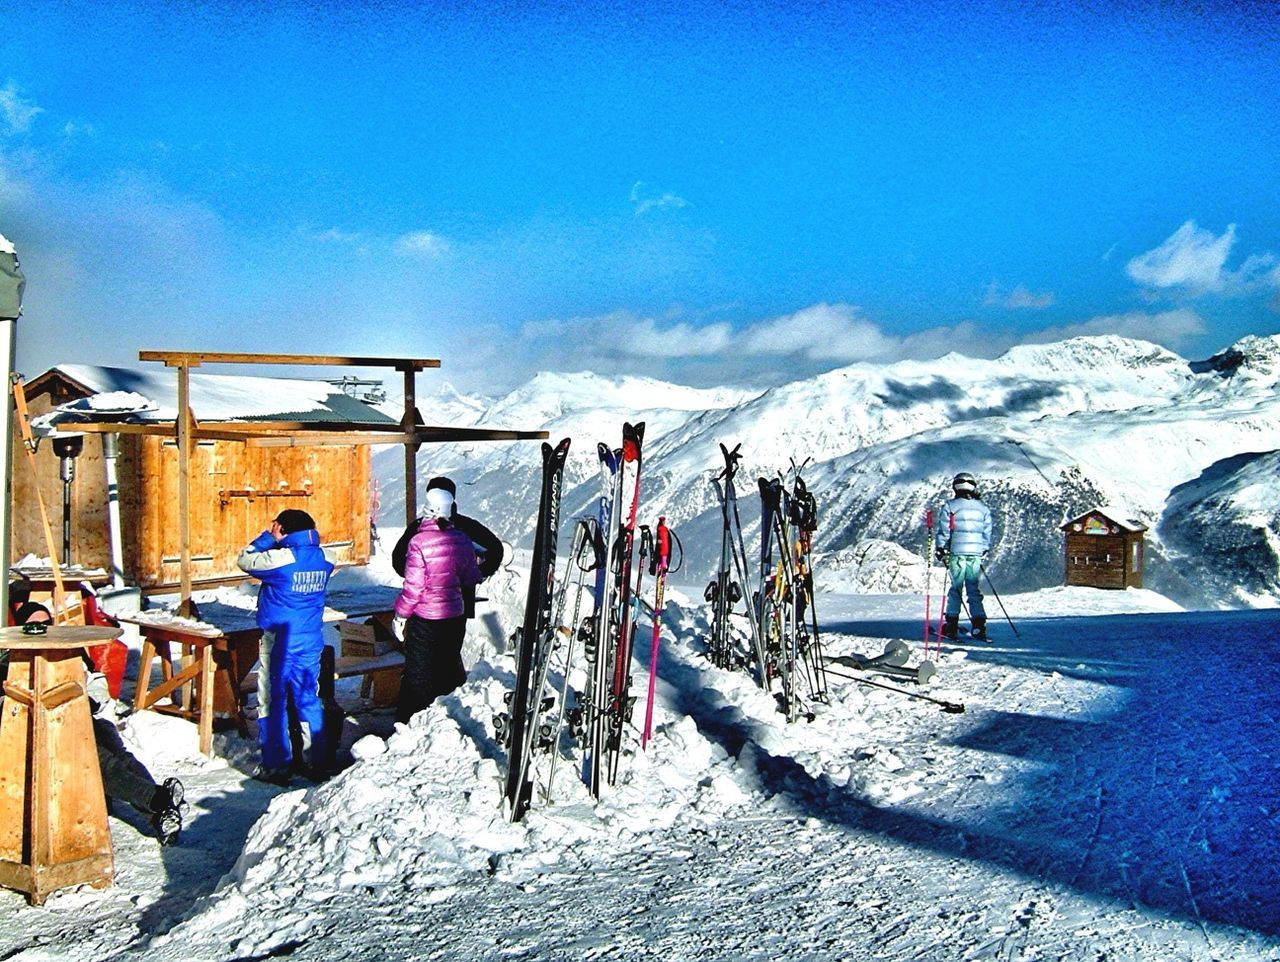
[145,583,781,957]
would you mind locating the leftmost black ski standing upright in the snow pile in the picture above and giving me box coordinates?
[494,438,570,821]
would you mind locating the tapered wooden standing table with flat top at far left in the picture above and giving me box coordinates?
[0,626,120,906]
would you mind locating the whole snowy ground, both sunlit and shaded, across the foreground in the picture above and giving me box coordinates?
[0,547,1280,962]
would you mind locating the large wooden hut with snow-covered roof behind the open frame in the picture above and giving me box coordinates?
[12,365,398,588]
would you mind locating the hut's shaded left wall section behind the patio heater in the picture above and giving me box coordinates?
[9,394,111,571]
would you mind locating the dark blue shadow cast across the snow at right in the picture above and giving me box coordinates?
[680,611,1280,935]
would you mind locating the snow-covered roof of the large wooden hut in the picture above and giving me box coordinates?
[32,365,396,425]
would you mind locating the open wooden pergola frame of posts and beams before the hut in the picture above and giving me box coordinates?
[64,351,548,614]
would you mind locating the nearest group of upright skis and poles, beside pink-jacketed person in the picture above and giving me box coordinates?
[495,422,673,821]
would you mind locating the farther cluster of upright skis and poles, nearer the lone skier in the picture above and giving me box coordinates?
[705,444,827,722]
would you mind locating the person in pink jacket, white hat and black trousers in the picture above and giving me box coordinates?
[393,487,480,724]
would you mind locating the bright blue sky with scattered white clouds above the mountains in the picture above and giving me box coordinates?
[0,0,1280,391]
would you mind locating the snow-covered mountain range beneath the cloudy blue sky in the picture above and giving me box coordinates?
[375,335,1280,606]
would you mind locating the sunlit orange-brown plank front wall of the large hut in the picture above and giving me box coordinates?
[120,436,371,587]
